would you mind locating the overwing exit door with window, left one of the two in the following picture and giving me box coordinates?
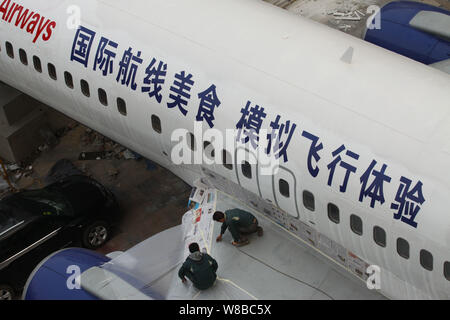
[236,147,261,196]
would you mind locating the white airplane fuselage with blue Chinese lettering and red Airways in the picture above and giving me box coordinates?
[0,0,450,299]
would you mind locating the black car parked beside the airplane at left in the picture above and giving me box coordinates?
[0,175,117,300]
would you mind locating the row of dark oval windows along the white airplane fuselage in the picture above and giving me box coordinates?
[0,42,450,281]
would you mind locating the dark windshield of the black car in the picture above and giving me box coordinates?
[13,189,72,216]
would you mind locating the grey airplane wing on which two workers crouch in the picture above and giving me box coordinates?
[102,185,385,300]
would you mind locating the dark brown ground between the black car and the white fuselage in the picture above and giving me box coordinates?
[9,120,191,253]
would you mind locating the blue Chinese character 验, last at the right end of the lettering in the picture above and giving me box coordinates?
[391,177,425,228]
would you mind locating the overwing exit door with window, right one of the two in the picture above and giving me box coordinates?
[272,166,300,218]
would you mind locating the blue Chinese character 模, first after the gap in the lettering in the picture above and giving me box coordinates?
[236,101,267,149]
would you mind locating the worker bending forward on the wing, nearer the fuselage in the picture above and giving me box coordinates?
[213,208,263,247]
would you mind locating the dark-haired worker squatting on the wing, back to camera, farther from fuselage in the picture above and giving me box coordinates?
[178,242,218,290]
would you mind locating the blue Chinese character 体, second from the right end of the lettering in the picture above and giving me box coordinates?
[359,160,391,208]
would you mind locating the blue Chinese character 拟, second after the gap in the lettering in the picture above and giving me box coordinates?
[266,115,297,162]
